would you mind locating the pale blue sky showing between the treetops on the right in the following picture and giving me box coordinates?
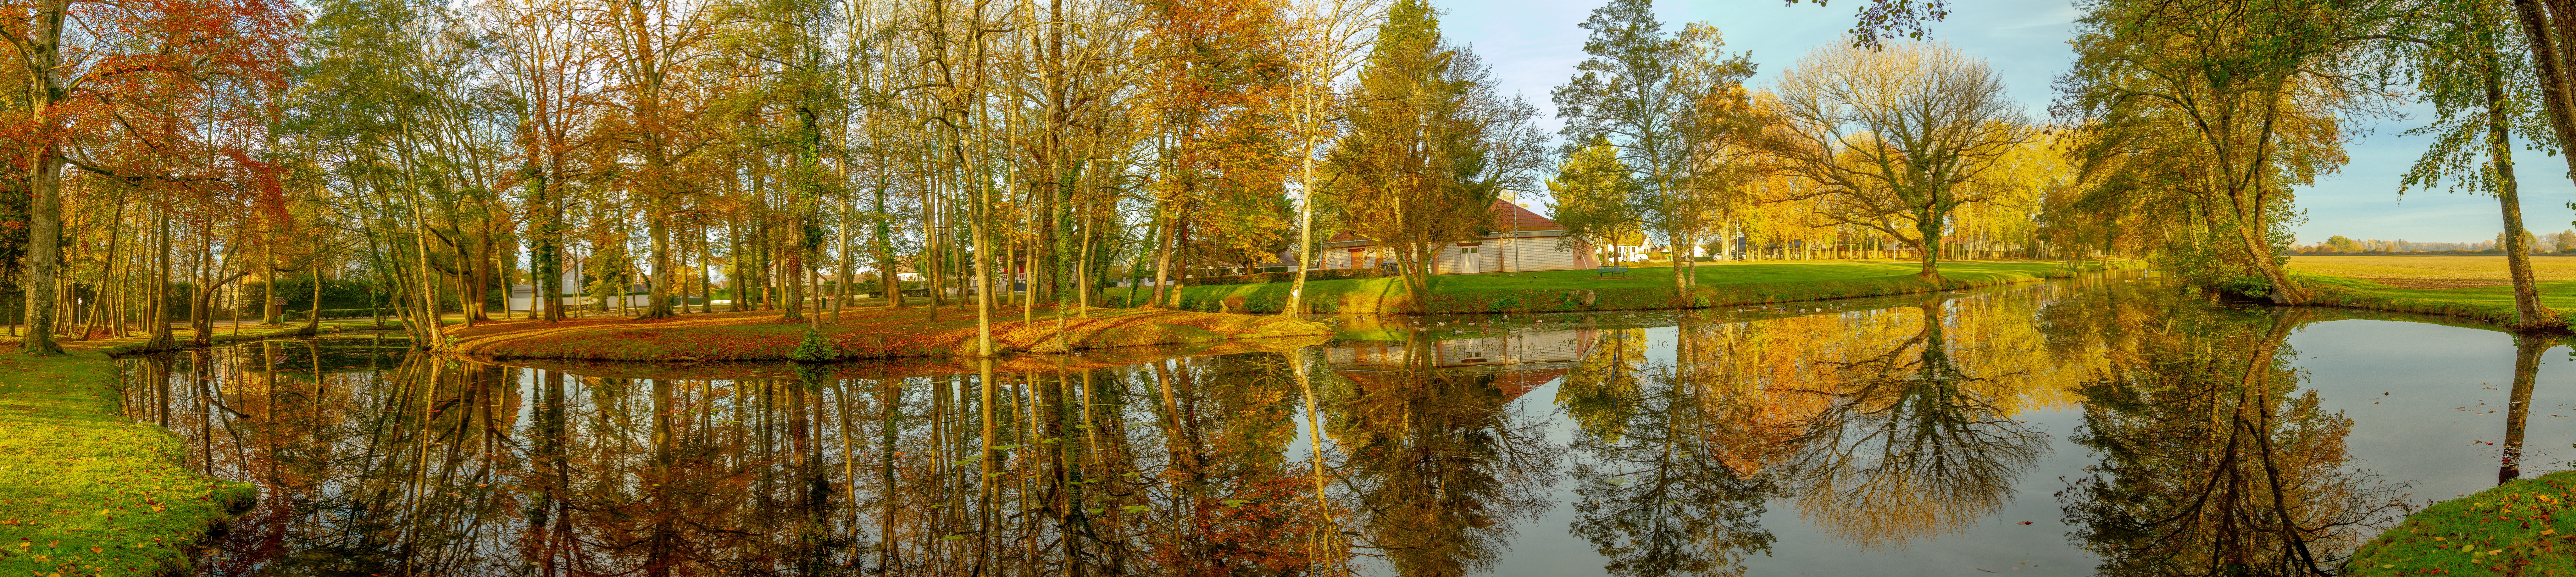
[1432,0,2576,242]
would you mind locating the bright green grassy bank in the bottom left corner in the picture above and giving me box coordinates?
[0,327,363,574]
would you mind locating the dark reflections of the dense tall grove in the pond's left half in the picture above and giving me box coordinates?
[124,332,1561,574]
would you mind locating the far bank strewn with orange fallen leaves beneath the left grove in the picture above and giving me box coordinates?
[448,307,1332,363]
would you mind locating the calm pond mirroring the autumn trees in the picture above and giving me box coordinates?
[124,276,2576,574]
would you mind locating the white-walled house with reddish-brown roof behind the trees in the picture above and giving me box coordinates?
[1316,201,1600,276]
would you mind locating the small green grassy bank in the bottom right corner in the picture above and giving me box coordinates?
[2344,471,2576,574]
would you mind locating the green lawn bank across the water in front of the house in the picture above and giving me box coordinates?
[1110,260,2099,314]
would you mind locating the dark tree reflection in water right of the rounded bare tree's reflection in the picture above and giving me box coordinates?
[2058,307,2403,574]
